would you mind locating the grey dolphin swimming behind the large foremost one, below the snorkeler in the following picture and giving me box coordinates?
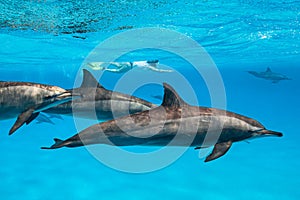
[45,69,157,120]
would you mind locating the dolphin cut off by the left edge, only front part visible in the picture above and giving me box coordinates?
[0,81,80,135]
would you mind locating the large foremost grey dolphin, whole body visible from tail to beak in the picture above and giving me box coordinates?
[42,84,282,162]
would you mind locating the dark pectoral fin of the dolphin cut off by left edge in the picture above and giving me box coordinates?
[9,108,39,135]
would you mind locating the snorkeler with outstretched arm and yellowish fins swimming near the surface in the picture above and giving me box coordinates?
[87,60,173,73]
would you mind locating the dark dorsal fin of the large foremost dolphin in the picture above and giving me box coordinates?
[161,83,187,108]
